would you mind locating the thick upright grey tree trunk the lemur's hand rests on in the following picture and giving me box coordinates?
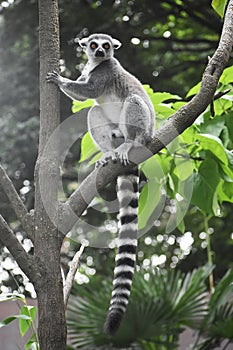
[34,0,66,350]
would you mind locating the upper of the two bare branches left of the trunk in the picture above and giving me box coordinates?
[0,165,34,241]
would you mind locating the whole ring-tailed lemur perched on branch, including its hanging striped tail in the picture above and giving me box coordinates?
[47,34,155,335]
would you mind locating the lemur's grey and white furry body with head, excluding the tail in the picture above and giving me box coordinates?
[47,34,155,164]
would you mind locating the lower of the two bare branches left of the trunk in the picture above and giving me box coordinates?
[0,215,35,281]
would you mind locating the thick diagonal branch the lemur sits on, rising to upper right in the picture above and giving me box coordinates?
[59,0,233,234]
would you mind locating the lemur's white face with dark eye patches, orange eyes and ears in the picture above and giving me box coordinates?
[79,34,121,60]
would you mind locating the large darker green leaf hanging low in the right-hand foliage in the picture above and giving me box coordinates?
[191,158,220,215]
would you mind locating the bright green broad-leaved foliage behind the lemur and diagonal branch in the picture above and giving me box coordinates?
[75,67,233,231]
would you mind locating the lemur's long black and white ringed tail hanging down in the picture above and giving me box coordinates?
[104,169,139,335]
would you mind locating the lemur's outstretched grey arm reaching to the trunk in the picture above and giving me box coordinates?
[47,63,110,101]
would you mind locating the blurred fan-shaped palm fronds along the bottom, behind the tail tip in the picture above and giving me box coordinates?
[67,266,233,350]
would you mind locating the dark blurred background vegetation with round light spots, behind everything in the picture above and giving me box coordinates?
[0,0,233,349]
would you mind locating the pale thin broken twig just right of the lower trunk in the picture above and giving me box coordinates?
[64,244,86,306]
